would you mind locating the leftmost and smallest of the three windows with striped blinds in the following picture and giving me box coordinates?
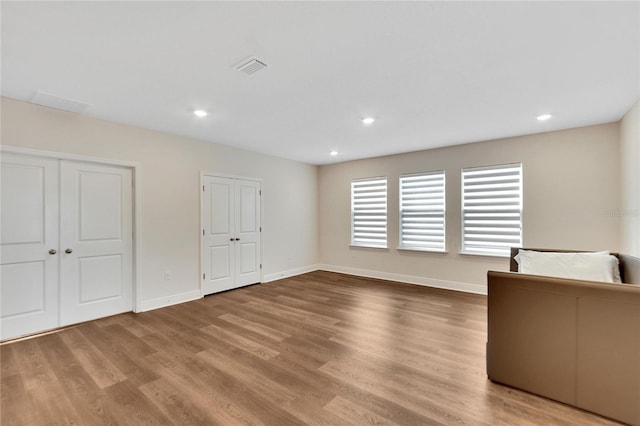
[351,177,387,247]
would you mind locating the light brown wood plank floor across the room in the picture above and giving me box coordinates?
[0,272,616,426]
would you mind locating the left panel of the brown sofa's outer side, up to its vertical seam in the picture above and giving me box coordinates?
[487,271,577,405]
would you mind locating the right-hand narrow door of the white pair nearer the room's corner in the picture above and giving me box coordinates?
[235,181,260,286]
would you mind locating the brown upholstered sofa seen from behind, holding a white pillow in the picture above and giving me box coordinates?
[487,249,640,426]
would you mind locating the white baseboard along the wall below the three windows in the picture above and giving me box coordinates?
[317,265,487,295]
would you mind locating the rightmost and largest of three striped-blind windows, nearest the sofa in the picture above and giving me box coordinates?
[462,164,522,256]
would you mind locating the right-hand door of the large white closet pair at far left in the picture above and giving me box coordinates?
[60,161,133,325]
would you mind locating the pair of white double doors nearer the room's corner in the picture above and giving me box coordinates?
[201,176,261,294]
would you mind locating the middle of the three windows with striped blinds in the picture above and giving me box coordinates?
[400,170,445,251]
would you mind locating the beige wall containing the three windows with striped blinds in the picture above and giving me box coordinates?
[318,123,620,292]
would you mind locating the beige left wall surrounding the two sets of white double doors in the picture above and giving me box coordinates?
[1,98,318,307]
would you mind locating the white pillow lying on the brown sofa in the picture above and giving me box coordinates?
[515,250,622,283]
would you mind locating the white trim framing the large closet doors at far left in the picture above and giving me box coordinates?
[0,145,142,313]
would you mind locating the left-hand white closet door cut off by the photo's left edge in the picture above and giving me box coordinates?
[0,154,60,340]
